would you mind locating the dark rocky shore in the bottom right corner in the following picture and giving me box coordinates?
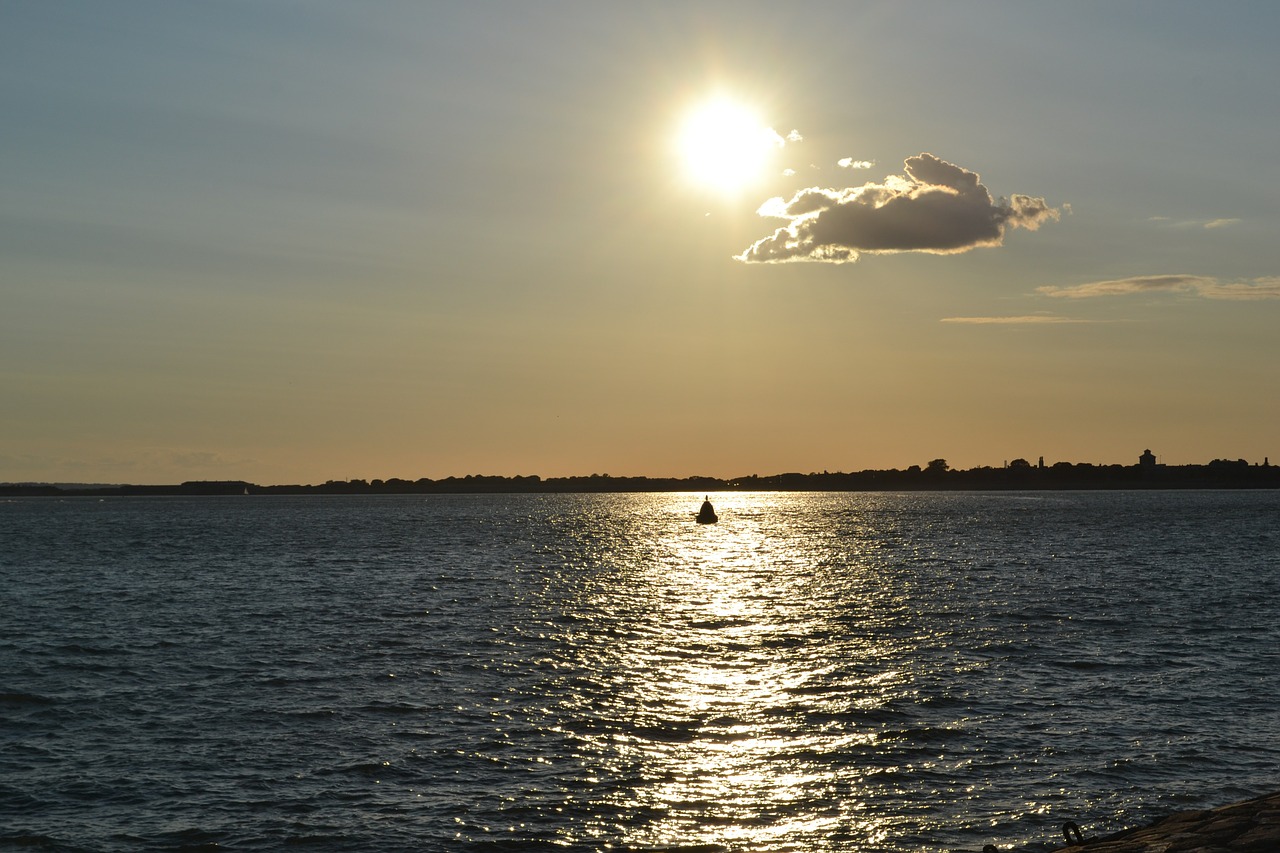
[1003,793,1280,853]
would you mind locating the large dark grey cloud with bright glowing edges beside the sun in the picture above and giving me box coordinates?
[736,154,1060,264]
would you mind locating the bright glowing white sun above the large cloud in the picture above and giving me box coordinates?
[676,99,783,192]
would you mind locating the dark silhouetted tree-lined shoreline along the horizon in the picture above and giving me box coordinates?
[0,460,1280,497]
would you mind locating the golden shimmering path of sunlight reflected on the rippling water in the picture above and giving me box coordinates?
[555,494,904,850]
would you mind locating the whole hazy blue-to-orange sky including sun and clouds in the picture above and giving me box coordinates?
[0,0,1280,484]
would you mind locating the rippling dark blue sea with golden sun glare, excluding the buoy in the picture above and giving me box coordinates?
[0,492,1280,852]
